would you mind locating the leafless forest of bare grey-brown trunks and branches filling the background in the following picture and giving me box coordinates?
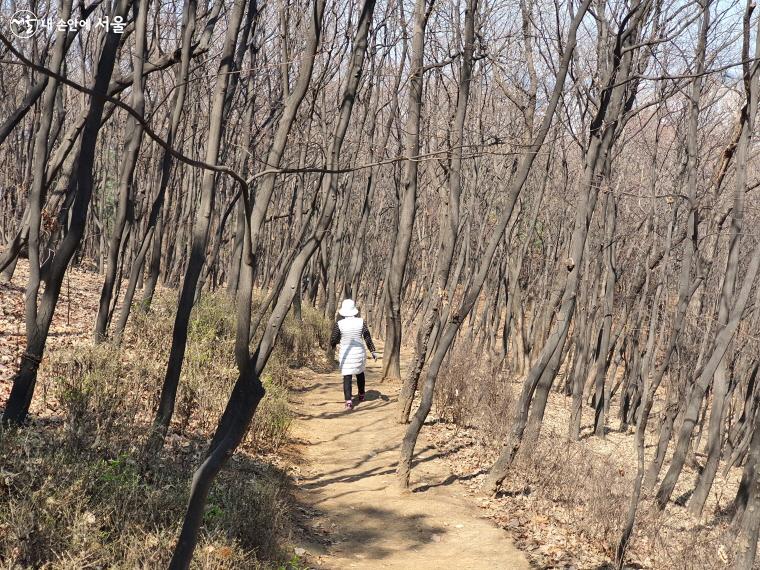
[0,0,760,568]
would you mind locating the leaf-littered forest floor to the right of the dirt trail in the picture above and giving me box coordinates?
[412,356,741,570]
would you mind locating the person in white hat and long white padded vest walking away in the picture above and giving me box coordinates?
[330,299,377,410]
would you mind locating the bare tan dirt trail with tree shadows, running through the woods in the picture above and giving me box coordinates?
[294,346,529,570]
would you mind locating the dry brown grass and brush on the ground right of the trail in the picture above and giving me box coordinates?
[424,342,735,570]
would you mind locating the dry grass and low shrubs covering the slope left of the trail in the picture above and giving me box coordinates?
[0,286,329,569]
